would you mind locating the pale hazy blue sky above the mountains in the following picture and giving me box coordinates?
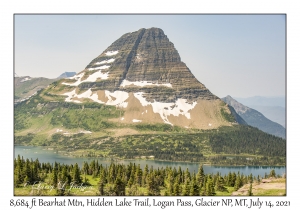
[15,15,286,97]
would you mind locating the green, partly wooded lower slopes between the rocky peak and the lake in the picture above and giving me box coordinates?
[15,94,286,165]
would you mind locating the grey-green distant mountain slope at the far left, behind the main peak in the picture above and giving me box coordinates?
[14,74,57,103]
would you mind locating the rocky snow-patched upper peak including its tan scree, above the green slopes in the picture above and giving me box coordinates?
[47,28,241,129]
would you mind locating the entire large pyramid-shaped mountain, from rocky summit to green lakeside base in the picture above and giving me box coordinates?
[14,28,286,165]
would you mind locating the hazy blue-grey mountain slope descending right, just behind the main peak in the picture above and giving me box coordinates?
[222,96,286,138]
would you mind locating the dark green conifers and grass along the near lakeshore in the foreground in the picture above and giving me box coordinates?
[14,156,279,196]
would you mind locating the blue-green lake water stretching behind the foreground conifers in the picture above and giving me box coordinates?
[15,146,286,176]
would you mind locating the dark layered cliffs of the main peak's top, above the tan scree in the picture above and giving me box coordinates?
[80,28,217,102]
